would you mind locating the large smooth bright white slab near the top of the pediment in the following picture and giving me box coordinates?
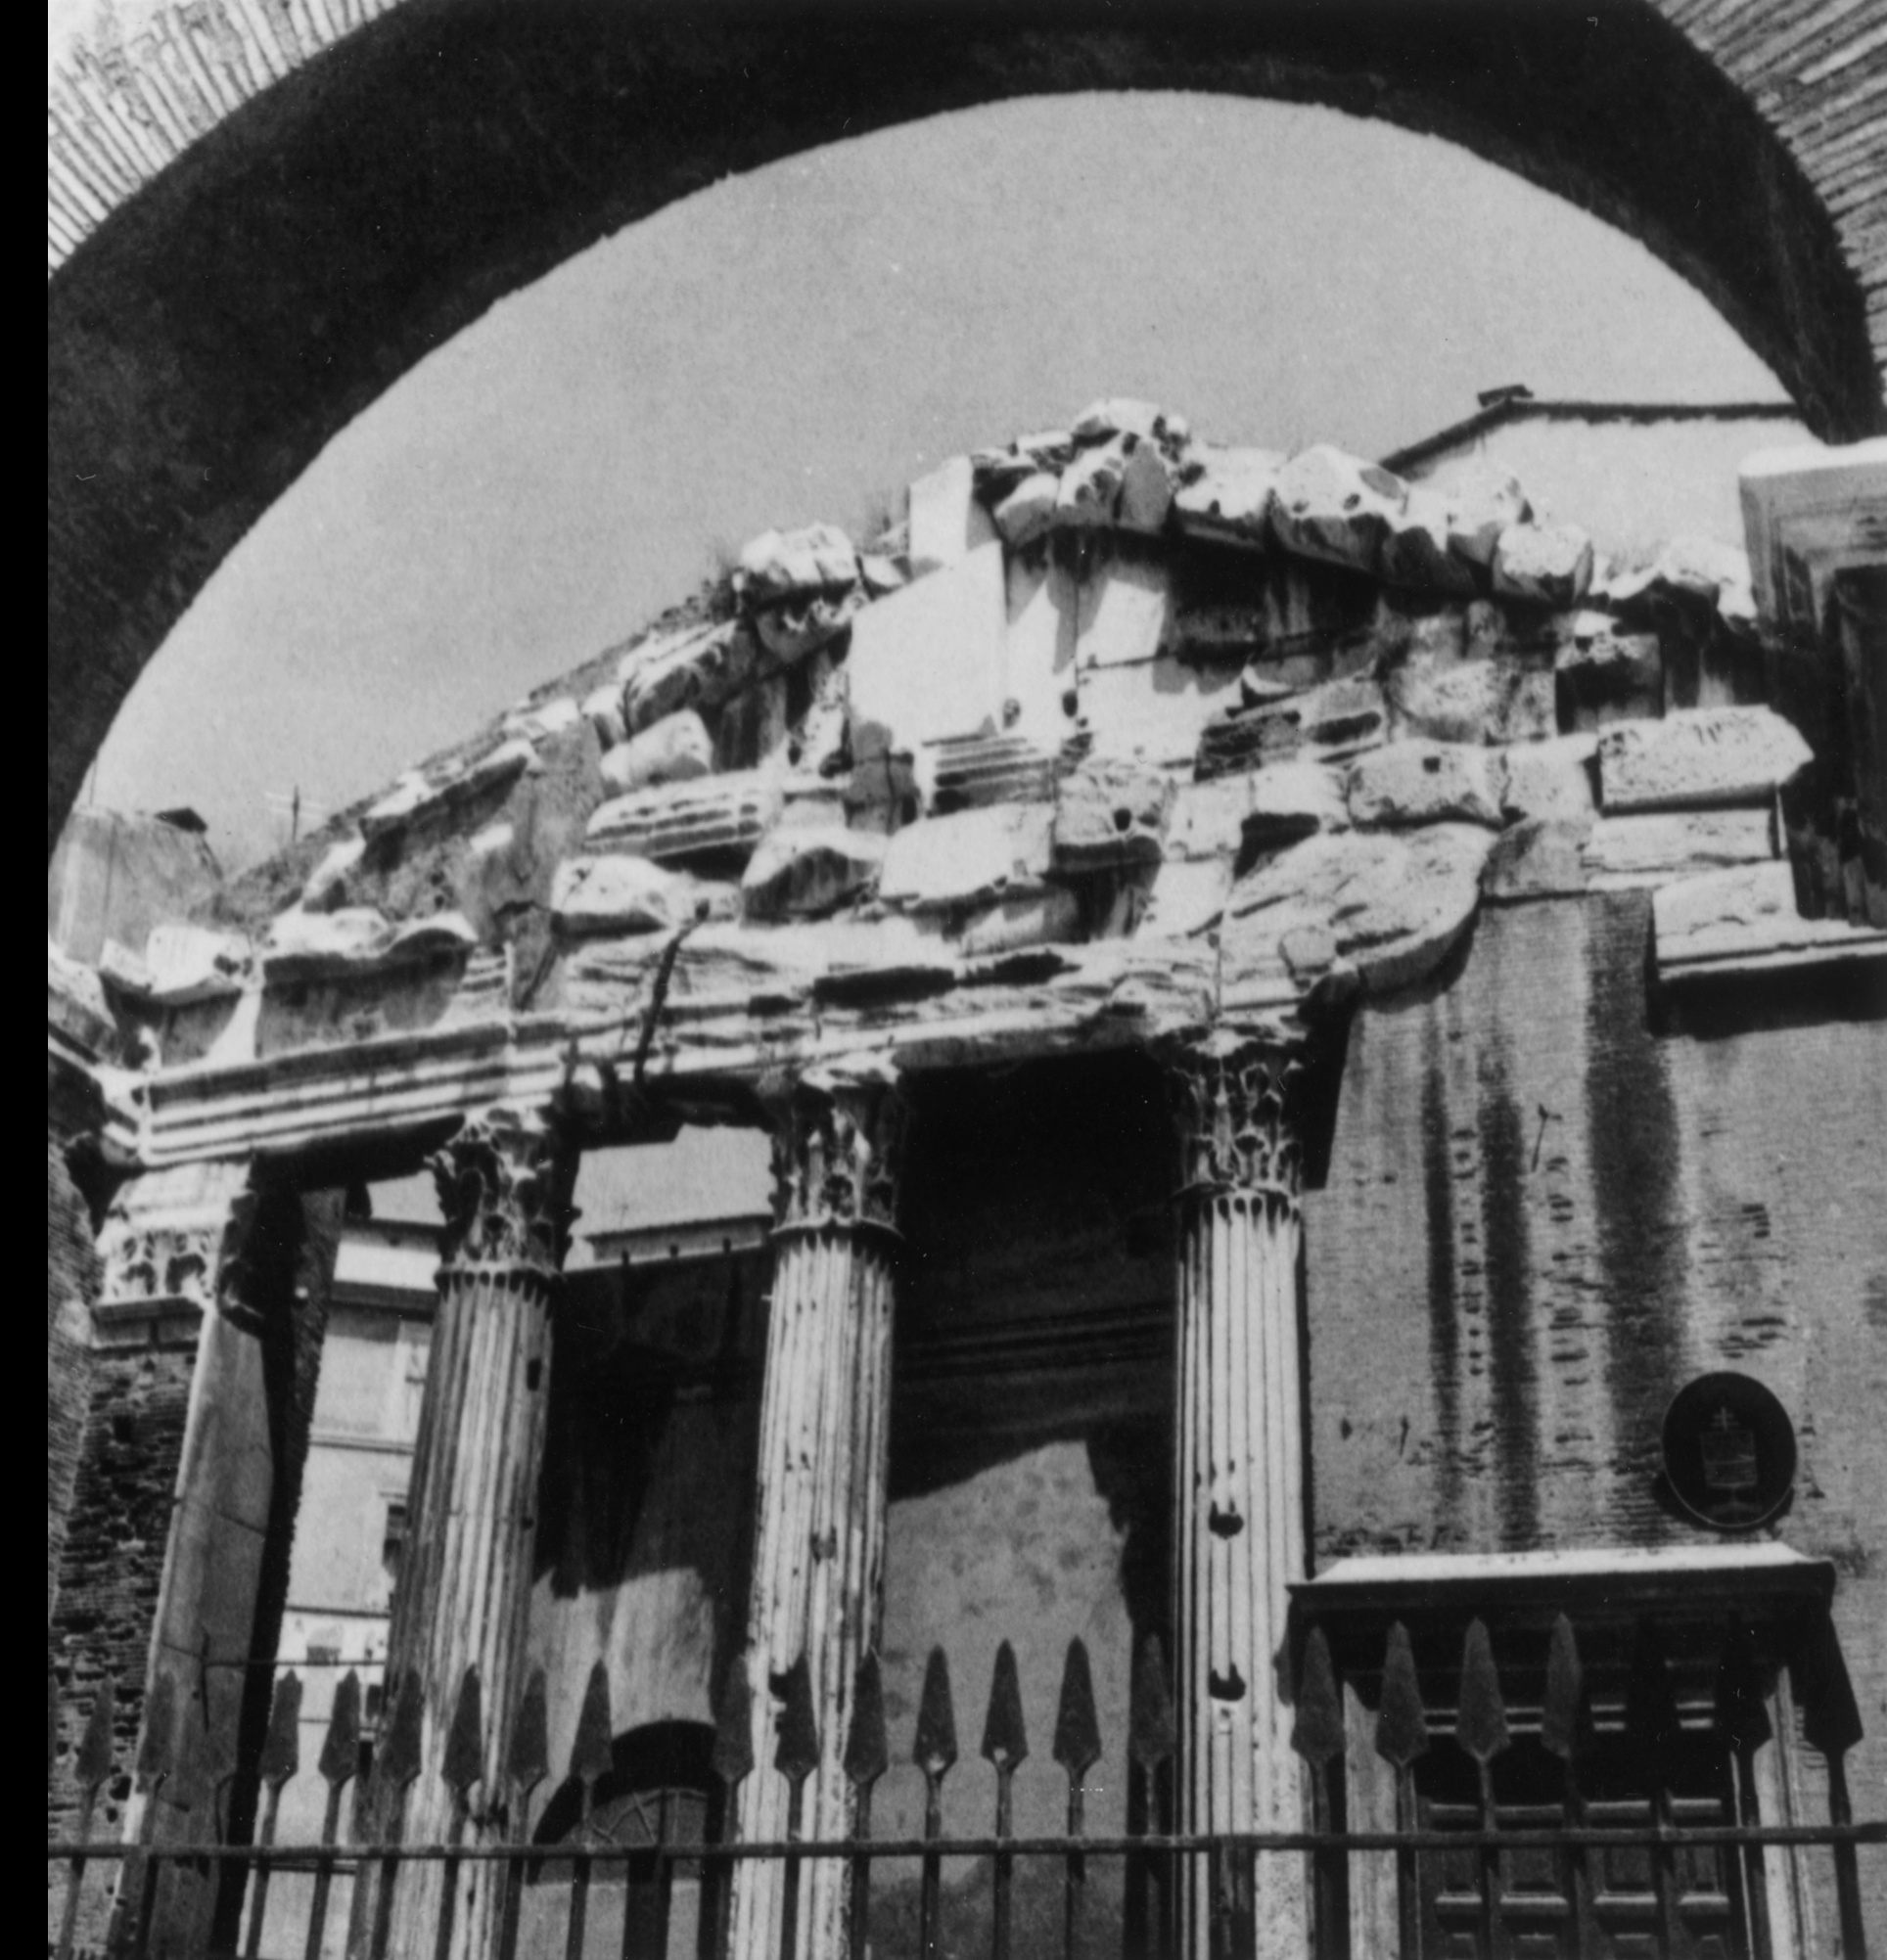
[845,543,1005,760]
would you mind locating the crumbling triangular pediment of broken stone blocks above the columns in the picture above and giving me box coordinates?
[67,400,1880,1073]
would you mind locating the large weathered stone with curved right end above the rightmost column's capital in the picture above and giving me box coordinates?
[1220,823,1494,994]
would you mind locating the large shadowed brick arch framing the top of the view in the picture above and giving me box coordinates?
[47,0,1887,846]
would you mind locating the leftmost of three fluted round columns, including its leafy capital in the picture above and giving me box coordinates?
[348,1110,571,1960]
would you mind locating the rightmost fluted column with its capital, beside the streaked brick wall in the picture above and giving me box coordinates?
[1170,1029,1309,1960]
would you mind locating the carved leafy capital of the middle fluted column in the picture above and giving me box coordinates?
[774,1069,907,1231]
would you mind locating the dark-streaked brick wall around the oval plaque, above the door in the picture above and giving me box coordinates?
[1307,893,1887,1951]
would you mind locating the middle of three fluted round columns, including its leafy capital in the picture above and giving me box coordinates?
[731,1074,903,1960]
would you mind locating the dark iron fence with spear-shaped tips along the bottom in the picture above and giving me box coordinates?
[47,1615,1887,1960]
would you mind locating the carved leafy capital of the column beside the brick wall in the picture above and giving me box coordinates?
[1168,1027,1305,1206]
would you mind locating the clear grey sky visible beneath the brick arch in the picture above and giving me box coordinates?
[92,96,1781,862]
